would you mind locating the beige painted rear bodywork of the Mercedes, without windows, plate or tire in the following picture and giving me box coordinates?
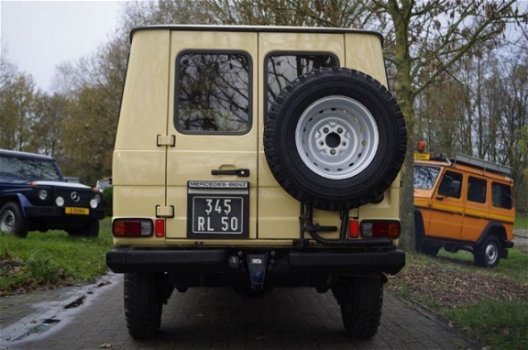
[113,29,400,246]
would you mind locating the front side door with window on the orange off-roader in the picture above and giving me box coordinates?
[426,170,464,239]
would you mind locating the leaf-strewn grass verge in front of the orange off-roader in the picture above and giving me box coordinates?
[388,249,528,349]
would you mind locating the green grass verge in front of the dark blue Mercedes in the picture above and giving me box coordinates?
[0,219,112,295]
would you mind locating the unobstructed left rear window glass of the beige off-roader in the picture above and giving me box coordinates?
[175,53,251,133]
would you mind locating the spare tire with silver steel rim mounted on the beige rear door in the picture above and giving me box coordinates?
[264,68,407,210]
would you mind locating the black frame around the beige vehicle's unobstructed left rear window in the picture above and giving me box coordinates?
[172,49,254,136]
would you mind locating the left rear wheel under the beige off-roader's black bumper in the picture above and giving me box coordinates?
[124,273,170,339]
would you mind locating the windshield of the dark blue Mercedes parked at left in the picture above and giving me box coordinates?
[0,156,62,181]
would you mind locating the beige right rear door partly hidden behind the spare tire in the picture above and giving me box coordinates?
[258,32,345,239]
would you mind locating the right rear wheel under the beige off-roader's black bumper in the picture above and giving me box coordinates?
[332,278,383,339]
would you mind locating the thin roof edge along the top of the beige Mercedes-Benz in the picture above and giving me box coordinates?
[130,24,383,44]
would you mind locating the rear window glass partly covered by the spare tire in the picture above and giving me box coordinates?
[266,53,339,111]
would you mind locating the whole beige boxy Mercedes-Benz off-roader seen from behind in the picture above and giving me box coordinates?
[107,26,407,338]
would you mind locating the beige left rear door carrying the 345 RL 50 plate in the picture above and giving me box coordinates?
[165,31,259,239]
